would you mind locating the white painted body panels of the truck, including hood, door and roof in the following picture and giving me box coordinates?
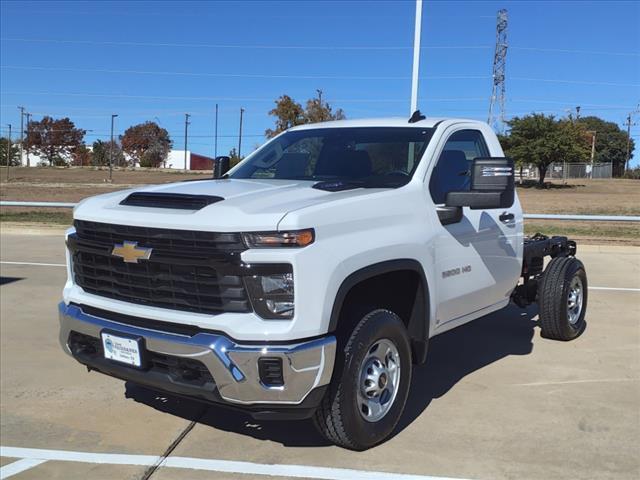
[64,119,523,341]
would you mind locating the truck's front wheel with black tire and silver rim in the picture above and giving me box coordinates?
[314,310,411,450]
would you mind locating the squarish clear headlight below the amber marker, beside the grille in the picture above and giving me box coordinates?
[245,273,294,319]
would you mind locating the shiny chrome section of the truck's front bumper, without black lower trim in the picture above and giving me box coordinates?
[58,302,336,405]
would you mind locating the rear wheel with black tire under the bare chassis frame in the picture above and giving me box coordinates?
[538,257,588,341]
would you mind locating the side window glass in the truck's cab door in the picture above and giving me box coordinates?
[429,130,489,204]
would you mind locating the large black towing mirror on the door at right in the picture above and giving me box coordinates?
[445,158,515,210]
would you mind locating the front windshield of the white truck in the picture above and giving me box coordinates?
[230,127,433,188]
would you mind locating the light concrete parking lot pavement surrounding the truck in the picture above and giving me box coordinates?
[0,231,640,480]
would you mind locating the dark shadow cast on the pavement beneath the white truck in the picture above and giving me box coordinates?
[125,306,537,447]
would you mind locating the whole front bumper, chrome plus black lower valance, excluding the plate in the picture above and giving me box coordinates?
[58,302,336,407]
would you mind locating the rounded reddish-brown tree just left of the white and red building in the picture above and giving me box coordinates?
[120,122,172,167]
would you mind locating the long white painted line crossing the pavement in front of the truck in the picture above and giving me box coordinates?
[0,447,470,480]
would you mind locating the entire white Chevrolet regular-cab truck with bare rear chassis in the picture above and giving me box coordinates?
[59,112,587,450]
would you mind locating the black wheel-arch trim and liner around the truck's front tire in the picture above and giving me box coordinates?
[329,259,430,364]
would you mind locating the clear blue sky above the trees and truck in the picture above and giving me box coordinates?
[0,1,640,164]
